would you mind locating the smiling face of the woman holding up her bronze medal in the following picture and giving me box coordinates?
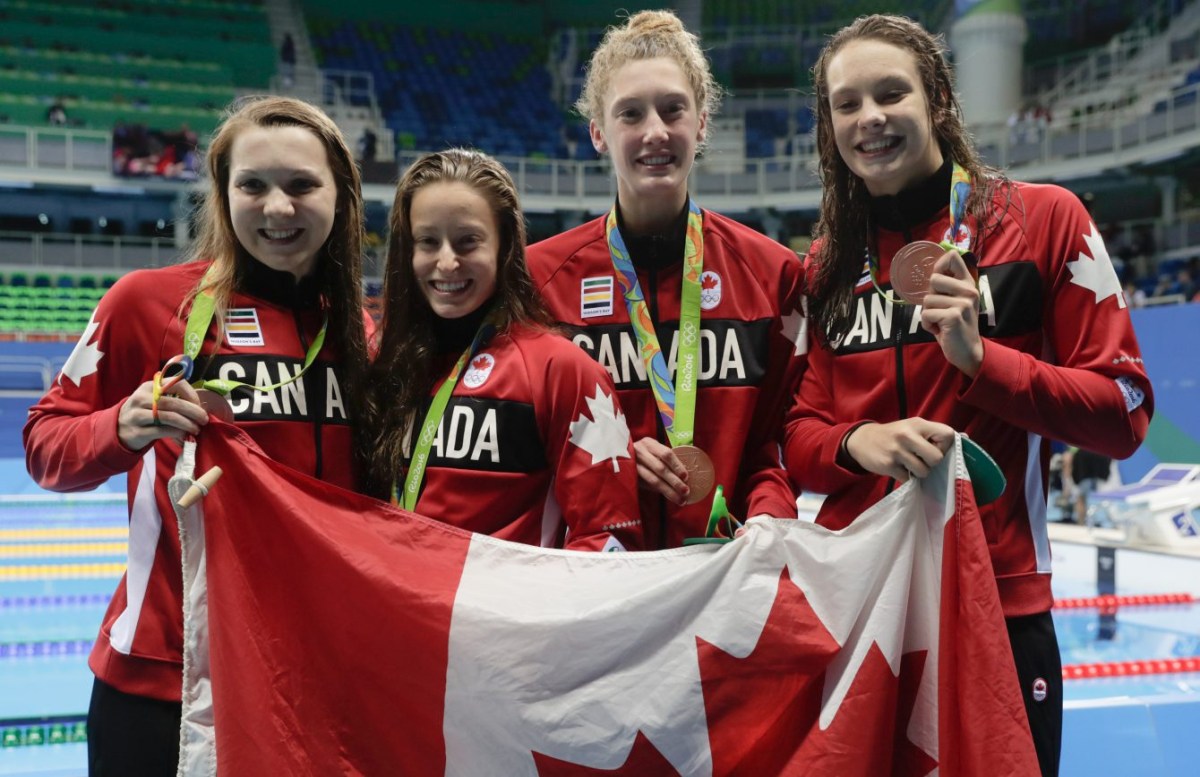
[827,38,942,197]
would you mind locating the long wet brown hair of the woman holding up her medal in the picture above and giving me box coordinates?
[809,14,1009,341]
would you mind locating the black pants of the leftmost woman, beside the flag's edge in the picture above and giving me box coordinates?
[88,680,182,777]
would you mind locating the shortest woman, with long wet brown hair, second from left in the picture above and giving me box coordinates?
[359,149,642,550]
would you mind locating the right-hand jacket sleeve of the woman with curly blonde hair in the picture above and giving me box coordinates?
[734,245,808,519]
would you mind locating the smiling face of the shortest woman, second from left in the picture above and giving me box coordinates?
[409,181,500,319]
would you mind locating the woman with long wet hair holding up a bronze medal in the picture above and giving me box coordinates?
[785,16,1152,775]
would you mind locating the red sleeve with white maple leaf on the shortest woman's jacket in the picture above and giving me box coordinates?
[538,341,644,550]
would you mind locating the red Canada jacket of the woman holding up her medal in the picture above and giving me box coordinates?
[785,183,1153,616]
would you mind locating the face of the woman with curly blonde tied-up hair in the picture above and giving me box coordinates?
[590,56,708,231]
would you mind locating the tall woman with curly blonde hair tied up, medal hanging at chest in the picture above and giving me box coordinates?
[529,11,805,548]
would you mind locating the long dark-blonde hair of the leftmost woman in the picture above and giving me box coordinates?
[181,96,367,418]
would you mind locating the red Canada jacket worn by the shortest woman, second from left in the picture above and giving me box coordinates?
[400,326,643,550]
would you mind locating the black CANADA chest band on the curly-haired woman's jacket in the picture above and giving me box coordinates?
[571,321,769,389]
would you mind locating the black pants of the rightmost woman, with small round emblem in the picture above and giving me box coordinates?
[1006,613,1062,777]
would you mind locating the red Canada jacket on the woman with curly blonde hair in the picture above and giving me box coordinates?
[529,211,806,549]
